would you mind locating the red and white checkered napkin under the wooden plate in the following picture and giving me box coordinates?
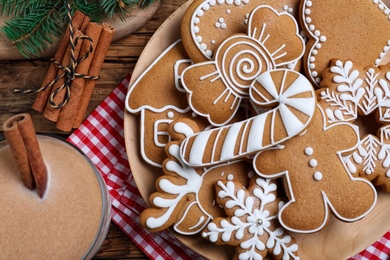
[68,75,390,260]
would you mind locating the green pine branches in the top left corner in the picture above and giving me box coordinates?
[0,0,156,58]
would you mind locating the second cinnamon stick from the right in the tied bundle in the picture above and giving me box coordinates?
[56,22,102,132]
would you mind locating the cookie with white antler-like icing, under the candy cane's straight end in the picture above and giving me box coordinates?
[140,119,254,235]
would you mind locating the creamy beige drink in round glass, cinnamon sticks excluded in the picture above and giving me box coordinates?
[0,136,110,259]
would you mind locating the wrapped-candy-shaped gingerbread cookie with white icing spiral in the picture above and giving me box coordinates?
[182,6,304,126]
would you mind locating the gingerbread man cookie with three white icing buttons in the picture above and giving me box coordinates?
[254,106,377,233]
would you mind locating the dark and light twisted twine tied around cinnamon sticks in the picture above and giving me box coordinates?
[14,3,100,109]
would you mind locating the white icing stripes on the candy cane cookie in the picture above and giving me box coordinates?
[181,69,316,167]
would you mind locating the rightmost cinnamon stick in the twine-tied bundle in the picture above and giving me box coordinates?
[73,23,114,128]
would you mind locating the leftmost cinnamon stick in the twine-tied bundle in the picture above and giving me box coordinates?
[32,11,89,112]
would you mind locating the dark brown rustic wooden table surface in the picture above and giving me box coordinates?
[0,0,186,259]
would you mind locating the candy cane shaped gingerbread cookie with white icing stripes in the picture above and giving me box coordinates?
[181,69,316,167]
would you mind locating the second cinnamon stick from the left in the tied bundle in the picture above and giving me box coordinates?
[43,30,83,122]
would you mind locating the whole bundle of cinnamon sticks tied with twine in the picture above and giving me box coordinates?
[32,11,114,132]
